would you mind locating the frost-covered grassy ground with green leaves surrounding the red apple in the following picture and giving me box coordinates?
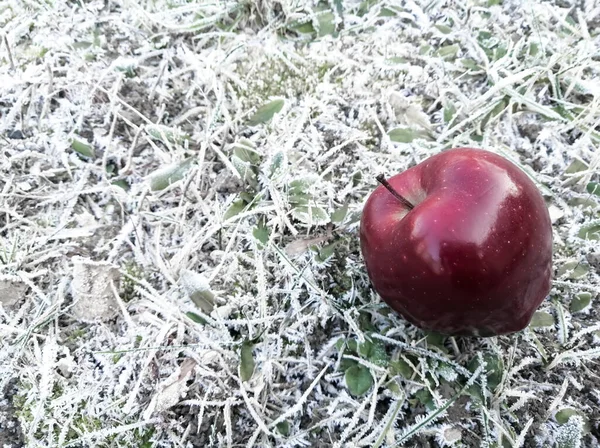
[0,0,600,448]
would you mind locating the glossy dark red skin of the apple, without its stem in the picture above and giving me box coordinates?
[360,148,552,337]
